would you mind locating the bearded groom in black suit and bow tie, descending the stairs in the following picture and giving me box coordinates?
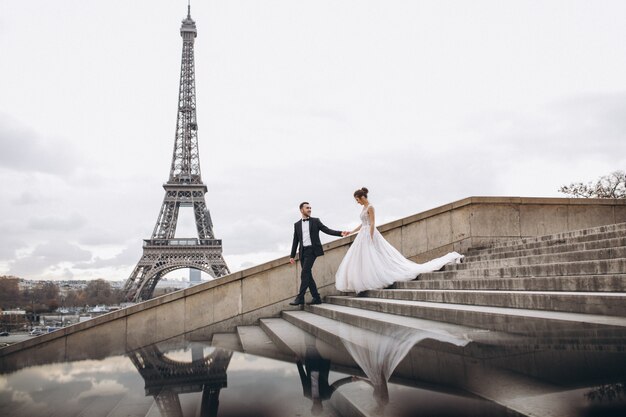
[289,201,348,306]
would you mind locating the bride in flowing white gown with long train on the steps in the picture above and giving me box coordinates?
[335,187,463,293]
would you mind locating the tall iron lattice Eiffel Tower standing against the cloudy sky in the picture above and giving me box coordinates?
[124,5,230,301]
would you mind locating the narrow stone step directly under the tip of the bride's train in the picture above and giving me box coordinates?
[445,246,626,271]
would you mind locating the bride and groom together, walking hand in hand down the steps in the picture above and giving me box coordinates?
[289,187,463,305]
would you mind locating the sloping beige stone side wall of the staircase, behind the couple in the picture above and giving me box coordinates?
[0,197,626,368]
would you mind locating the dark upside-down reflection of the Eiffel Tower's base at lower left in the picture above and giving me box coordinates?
[128,345,233,417]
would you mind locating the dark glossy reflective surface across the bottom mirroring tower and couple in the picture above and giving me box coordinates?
[0,316,626,417]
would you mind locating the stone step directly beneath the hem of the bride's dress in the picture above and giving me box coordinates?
[365,289,626,316]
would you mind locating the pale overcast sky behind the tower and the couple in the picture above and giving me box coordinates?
[0,0,626,280]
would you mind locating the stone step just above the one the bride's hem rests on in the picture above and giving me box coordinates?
[392,274,626,292]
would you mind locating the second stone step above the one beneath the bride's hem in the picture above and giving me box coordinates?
[419,258,626,280]
